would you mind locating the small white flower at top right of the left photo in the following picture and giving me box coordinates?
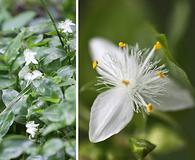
[58,19,75,33]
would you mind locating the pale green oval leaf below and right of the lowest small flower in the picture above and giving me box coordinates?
[43,138,64,157]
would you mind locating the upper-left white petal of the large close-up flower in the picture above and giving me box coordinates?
[90,38,128,85]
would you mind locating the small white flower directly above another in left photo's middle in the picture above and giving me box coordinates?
[24,49,38,65]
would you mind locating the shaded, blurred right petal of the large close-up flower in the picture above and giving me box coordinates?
[154,79,194,111]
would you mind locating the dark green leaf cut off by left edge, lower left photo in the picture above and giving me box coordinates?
[0,110,15,139]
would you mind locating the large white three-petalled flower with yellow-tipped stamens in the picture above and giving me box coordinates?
[89,38,194,143]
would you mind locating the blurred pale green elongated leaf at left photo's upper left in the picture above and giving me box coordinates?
[2,11,35,31]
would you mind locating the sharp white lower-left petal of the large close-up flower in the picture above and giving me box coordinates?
[89,87,133,143]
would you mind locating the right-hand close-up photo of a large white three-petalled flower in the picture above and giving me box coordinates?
[78,0,195,160]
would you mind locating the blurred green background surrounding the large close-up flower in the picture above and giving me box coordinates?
[79,0,195,160]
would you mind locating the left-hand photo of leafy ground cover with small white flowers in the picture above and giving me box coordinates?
[0,0,77,160]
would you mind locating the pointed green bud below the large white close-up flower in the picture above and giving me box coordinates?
[129,138,156,160]
